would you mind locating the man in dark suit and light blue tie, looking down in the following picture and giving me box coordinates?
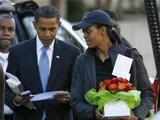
[6,6,79,120]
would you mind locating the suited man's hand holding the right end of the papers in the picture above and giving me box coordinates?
[55,92,71,103]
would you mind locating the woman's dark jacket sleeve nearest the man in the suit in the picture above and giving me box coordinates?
[71,57,95,120]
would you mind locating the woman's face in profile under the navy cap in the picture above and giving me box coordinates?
[83,25,103,48]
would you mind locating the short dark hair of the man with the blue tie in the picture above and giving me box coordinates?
[34,5,60,22]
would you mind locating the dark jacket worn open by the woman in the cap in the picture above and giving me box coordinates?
[71,44,153,120]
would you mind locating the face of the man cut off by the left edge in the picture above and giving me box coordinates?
[0,18,15,49]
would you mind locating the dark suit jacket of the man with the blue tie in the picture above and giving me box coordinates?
[6,40,79,120]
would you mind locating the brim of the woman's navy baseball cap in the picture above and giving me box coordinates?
[72,21,91,30]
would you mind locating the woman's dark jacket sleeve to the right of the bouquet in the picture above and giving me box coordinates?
[130,49,153,120]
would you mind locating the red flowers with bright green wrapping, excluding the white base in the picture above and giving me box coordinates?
[85,78,140,116]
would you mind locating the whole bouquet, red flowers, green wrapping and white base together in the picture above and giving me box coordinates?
[85,78,141,117]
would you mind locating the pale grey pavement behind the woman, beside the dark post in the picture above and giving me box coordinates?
[119,15,156,77]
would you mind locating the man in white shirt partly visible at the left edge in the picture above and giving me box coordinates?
[0,13,15,120]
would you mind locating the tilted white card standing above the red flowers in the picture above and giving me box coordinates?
[112,54,133,80]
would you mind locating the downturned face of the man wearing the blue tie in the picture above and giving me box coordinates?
[34,17,60,47]
